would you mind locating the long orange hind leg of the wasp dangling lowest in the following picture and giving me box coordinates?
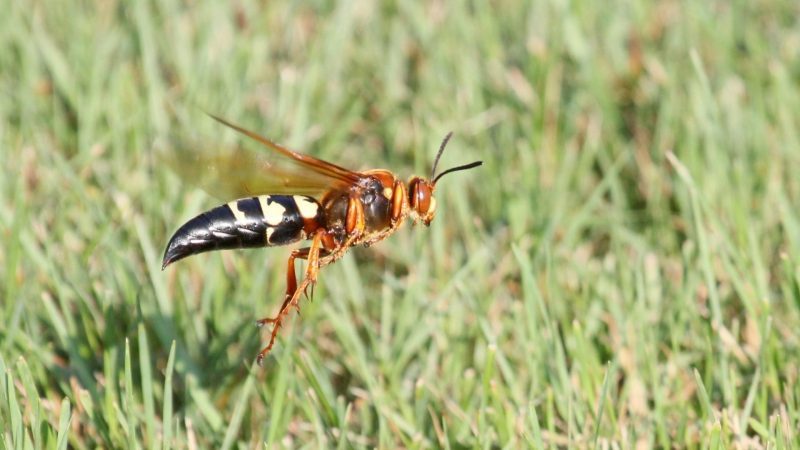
[256,230,328,365]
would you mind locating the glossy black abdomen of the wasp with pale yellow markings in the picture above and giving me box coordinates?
[162,195,325,269]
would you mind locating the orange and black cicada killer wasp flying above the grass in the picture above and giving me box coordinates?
[162,115,482,364]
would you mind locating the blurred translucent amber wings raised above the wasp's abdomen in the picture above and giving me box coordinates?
[164,115,362,201]
